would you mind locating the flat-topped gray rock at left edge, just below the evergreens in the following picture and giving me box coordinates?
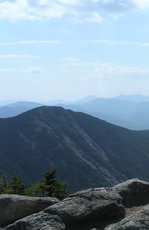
[0,195,58,227]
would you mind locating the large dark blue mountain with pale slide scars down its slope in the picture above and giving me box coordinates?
[0,106,149,192]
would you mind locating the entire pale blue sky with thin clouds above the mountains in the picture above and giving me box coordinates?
[0,0,149,101]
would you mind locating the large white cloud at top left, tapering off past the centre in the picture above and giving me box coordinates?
[0,0,102,23]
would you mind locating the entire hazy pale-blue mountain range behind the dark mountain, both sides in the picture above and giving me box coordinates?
[0,95,149,130]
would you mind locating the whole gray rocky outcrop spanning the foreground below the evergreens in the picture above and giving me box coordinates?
[0,179,149,230]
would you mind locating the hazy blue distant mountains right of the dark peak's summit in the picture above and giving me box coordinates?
[58,95,149,130]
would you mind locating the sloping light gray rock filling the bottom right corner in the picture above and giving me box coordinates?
[105,205,149,230]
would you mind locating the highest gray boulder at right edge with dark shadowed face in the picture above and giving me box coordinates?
[113,179,149,207]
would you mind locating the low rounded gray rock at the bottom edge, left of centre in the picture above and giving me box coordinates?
[5,212,65,230]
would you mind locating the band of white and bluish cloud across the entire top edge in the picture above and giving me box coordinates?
[0,0,149,23]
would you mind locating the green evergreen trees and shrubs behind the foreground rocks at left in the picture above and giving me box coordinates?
[0,169,67,199]
